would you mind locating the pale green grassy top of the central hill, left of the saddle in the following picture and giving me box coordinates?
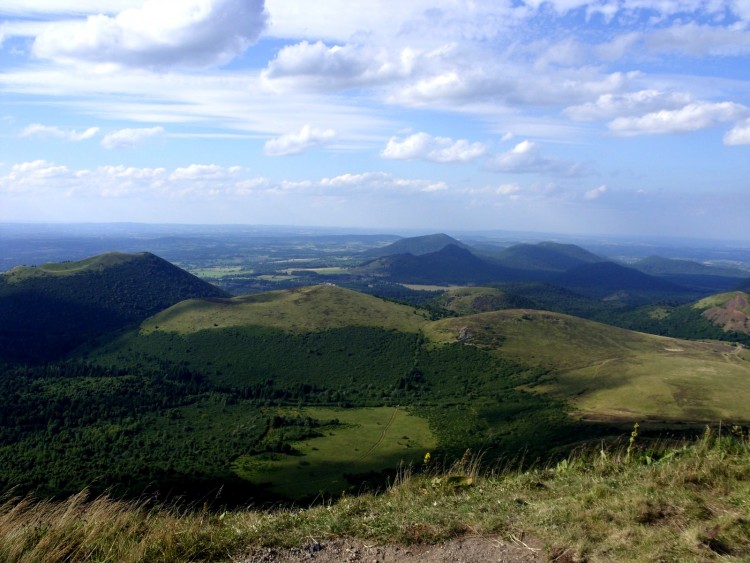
[141,285,426,334]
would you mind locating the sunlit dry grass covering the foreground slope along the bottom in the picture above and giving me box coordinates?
[0,428,750,563]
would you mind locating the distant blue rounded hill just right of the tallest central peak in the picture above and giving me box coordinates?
[494,242,604,272]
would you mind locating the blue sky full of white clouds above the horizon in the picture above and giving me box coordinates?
[0,0,750,241]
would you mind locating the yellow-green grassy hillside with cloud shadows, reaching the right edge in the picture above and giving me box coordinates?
[426,310,750,422]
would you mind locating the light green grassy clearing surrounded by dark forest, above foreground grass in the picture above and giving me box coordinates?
[233,407,436,498]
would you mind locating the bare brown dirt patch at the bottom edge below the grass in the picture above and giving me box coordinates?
[233,537,549,563]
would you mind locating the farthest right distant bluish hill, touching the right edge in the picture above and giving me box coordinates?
[631,256,747,293]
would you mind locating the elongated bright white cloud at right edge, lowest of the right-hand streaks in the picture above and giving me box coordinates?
[609,102,747,135]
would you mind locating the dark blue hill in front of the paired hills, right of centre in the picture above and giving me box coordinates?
[550,262,688,301]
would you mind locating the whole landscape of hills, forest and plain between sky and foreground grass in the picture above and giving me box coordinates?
[0,225,750,505]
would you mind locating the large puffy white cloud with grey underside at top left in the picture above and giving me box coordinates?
[32,0,266,68]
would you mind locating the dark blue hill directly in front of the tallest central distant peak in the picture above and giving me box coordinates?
[353,244,516,284]
